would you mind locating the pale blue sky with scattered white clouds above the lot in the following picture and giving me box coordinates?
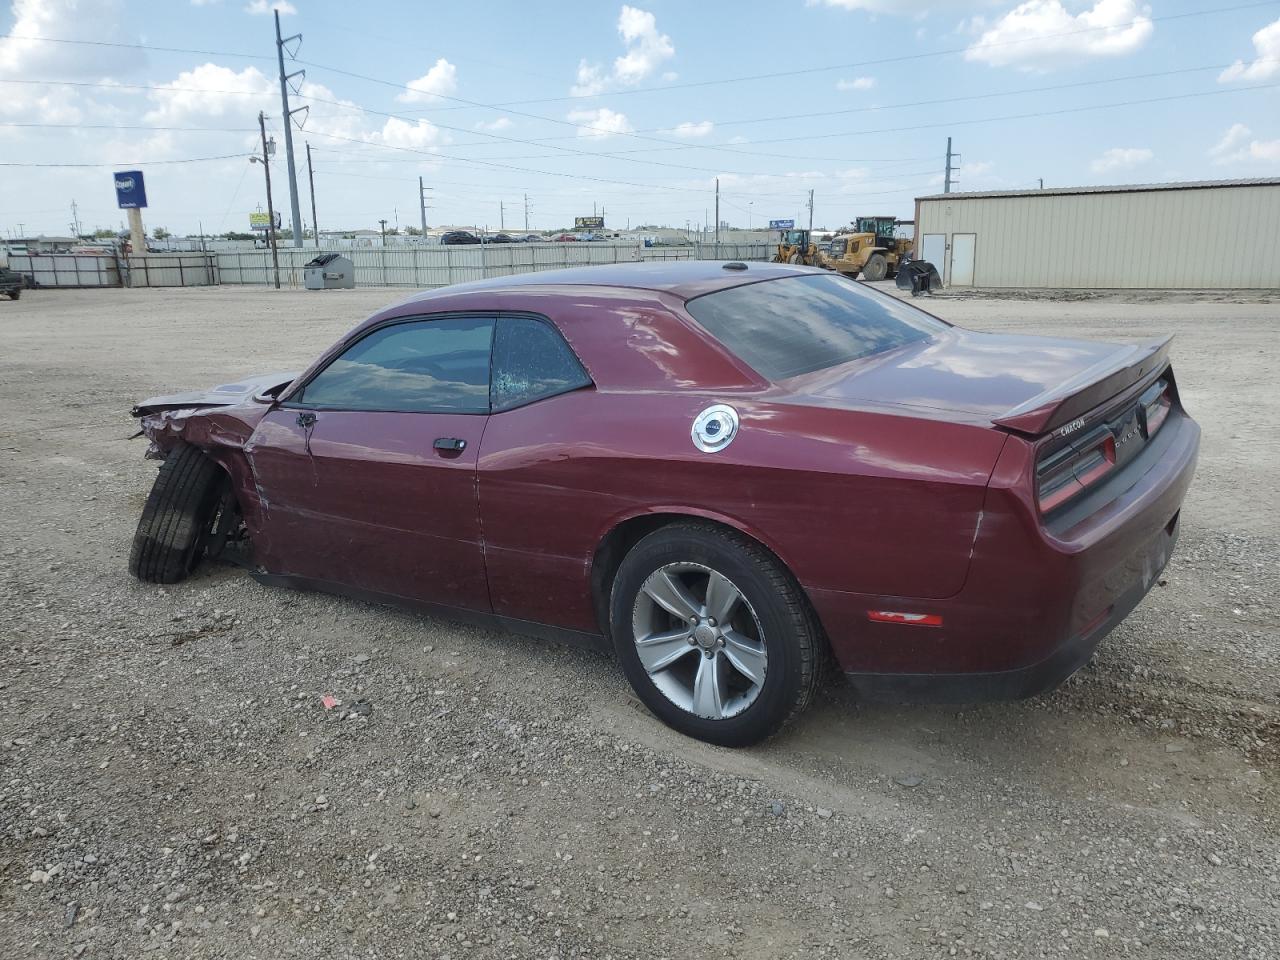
[0,0,1280,234]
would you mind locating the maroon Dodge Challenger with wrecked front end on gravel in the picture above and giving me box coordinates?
[129,262,1199,745]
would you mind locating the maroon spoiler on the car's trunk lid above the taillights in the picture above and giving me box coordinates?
[992,334,1174,436]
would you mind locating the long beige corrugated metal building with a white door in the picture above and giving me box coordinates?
[915,179,1280,289]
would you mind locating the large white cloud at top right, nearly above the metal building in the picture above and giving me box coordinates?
[965,0,1155,70]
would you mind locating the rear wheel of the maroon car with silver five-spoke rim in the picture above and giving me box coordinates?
[609,522,823,746]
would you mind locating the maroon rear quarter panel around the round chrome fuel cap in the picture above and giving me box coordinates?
[479,389,1004,632]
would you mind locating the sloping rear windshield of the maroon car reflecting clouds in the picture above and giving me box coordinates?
[686,274,946,380]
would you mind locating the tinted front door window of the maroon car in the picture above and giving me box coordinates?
[289,316,494,413]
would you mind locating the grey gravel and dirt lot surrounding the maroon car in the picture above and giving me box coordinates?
[0,288,1280,960]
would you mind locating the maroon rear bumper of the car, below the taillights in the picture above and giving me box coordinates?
[810,411,1199,703]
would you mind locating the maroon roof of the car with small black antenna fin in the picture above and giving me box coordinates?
[391,260,824,306]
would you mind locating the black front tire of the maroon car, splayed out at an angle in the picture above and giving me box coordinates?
[129,443,228,584]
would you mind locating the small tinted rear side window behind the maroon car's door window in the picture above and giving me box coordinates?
[493,316,591,411]
